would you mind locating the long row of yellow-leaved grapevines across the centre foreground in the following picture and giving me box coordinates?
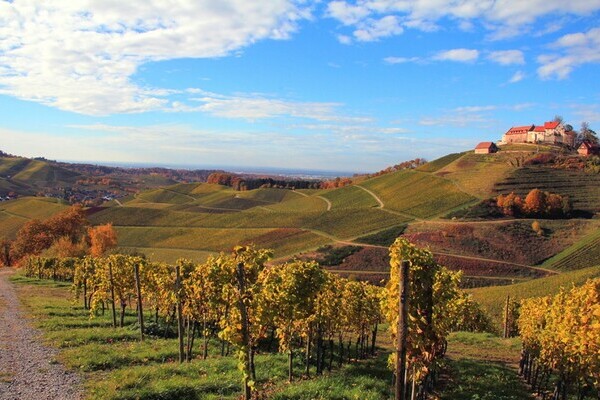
[16,239,496,398]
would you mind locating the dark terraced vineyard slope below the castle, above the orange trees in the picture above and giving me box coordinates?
[494,166,600,213]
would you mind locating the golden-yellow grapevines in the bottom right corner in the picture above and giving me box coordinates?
[518,279,600,400]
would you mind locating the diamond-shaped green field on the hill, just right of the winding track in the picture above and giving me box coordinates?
[361,170,475,218]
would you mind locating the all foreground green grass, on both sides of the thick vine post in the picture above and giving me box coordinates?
[12,275,540,400]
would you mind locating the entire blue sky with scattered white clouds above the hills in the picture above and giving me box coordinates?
[0,0,600,172]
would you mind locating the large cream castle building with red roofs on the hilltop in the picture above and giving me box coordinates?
[502,121,575,147]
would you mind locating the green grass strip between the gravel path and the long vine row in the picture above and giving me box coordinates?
[12,275,390,400]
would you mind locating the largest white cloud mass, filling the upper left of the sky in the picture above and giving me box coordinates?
[0,0,308,115]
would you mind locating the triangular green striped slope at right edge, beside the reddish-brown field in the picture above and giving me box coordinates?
[542,229,600,271]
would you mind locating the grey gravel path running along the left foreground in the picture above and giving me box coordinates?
[0,268,82,400]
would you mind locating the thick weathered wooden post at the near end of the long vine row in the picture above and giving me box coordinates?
[395,261,409,400]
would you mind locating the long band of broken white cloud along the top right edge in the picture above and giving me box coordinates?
[327,0,600,39]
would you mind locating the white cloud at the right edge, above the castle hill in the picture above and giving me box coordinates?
[537,28,600,79]
